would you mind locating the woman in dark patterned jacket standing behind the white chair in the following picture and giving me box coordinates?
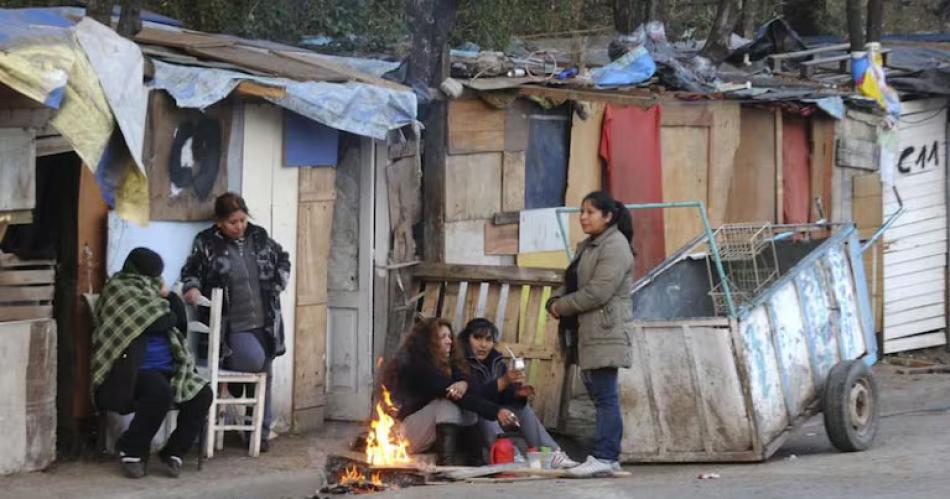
[181,192,290,452]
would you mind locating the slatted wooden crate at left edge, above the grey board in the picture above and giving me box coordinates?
[0,253,56,322]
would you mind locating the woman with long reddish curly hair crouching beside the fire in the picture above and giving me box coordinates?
[386,318,518,466]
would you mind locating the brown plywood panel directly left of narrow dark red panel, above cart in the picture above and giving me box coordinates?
[726,107,777,223]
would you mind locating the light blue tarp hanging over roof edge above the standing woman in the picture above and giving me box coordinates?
[151,60,416,140]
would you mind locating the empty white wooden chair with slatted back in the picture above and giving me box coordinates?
[188,288,267,458]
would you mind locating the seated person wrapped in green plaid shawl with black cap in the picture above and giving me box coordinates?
[92,248,212,478]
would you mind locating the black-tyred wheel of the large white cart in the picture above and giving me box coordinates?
[822,360,878,452]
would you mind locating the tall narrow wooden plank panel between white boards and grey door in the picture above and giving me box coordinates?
[293,167,336,431]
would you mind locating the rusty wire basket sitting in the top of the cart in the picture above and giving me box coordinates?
[706,224,779,315]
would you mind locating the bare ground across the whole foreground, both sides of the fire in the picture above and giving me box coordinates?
[0,364,950,499]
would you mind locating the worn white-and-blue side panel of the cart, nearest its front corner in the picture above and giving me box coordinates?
[739,306,789,443]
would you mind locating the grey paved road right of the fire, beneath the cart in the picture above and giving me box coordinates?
[379,366,950,499]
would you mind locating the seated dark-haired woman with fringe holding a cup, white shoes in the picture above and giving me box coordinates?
[458,318,578,469]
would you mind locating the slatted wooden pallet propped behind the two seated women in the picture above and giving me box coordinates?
[413,263,573,428]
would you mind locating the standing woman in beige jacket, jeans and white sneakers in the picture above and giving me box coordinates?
[547,191,634,476]
